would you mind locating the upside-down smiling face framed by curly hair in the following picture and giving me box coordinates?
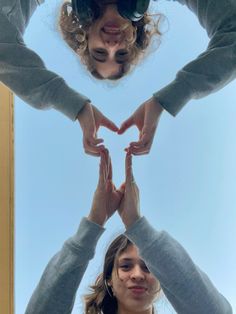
[88,1,134,78]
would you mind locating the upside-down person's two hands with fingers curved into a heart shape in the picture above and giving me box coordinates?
[77,97,163,156]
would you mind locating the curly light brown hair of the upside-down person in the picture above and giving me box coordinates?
[59,1,162,80]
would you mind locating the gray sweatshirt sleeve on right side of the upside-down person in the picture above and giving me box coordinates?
[154,0,236,116]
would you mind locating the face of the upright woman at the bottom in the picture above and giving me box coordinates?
[109,245,159,314]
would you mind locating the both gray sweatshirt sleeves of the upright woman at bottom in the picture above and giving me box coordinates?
[25,217,232,314]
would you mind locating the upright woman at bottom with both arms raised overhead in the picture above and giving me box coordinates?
[25,150,232,314]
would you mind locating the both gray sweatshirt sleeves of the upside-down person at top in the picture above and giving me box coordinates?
[0,0,236,120]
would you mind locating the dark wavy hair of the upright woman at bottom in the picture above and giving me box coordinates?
[84,234,161,314]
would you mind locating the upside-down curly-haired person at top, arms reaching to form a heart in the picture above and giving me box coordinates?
[0,0,236,156]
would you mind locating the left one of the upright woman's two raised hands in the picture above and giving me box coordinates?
[88,149,123,226]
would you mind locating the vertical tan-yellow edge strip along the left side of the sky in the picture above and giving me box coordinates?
[0,83,14,314]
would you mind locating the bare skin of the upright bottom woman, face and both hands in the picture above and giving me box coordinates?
[88,150,159,314]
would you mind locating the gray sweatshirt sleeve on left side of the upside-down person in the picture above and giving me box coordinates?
[0,0,90,120]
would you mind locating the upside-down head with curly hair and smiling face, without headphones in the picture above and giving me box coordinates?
[59,0,161,80]
